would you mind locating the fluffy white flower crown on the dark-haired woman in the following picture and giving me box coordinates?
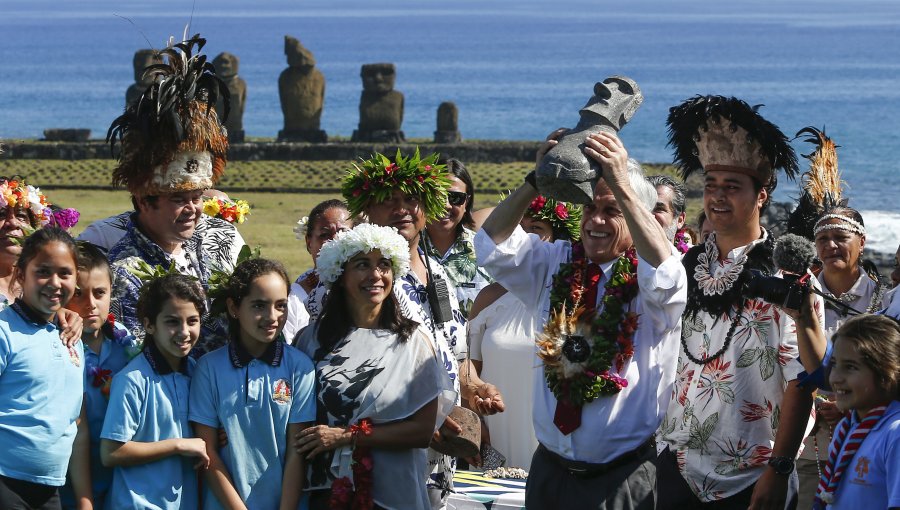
[316,223,409,288]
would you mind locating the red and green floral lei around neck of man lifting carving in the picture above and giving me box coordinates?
[542,243,638,406]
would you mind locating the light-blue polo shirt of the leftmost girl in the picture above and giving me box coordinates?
[0,301,84,487]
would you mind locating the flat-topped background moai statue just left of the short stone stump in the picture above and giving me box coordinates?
[352,64,406,143]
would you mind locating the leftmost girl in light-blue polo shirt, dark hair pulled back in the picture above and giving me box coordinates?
[0,227,91,509]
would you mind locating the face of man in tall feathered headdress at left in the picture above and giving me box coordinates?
[138,190,203,253]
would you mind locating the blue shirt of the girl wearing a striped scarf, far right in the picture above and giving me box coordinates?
[827,400,900,508]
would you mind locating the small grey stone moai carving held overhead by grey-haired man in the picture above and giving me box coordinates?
[535,76,644,204]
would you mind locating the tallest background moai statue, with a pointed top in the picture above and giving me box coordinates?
[278,35,328,142]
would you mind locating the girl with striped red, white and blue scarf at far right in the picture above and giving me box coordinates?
[814,315,900,509]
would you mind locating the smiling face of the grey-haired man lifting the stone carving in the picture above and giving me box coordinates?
[581,179,632,264]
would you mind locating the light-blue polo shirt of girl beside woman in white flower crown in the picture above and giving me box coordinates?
[190,341,316,509]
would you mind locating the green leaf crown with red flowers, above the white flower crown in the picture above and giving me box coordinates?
[341,147,450,221]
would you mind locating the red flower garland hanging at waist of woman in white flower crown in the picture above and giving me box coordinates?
[328,418,375,510]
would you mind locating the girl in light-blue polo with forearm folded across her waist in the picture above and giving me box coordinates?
[100,274,209,510]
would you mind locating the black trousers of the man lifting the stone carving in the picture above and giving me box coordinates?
[525,447,656,510]
